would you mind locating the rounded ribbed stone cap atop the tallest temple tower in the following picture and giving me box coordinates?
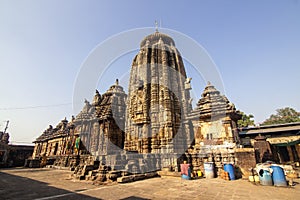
[140,31,175,48]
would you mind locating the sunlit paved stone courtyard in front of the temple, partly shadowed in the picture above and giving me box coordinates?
[0,168,300,200]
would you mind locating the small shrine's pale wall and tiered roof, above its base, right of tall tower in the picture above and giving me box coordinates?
[189,83,241,149]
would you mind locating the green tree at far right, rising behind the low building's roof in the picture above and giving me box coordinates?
[262,107,300,125]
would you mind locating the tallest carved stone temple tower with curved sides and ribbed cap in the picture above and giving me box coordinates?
[125,31,192,156]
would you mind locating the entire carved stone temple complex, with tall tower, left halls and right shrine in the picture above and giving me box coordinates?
[33,31,288,181]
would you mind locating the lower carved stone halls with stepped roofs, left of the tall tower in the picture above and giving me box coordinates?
[33,80,127,163]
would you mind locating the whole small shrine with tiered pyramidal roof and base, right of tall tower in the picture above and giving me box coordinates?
[183,82,247,177]
